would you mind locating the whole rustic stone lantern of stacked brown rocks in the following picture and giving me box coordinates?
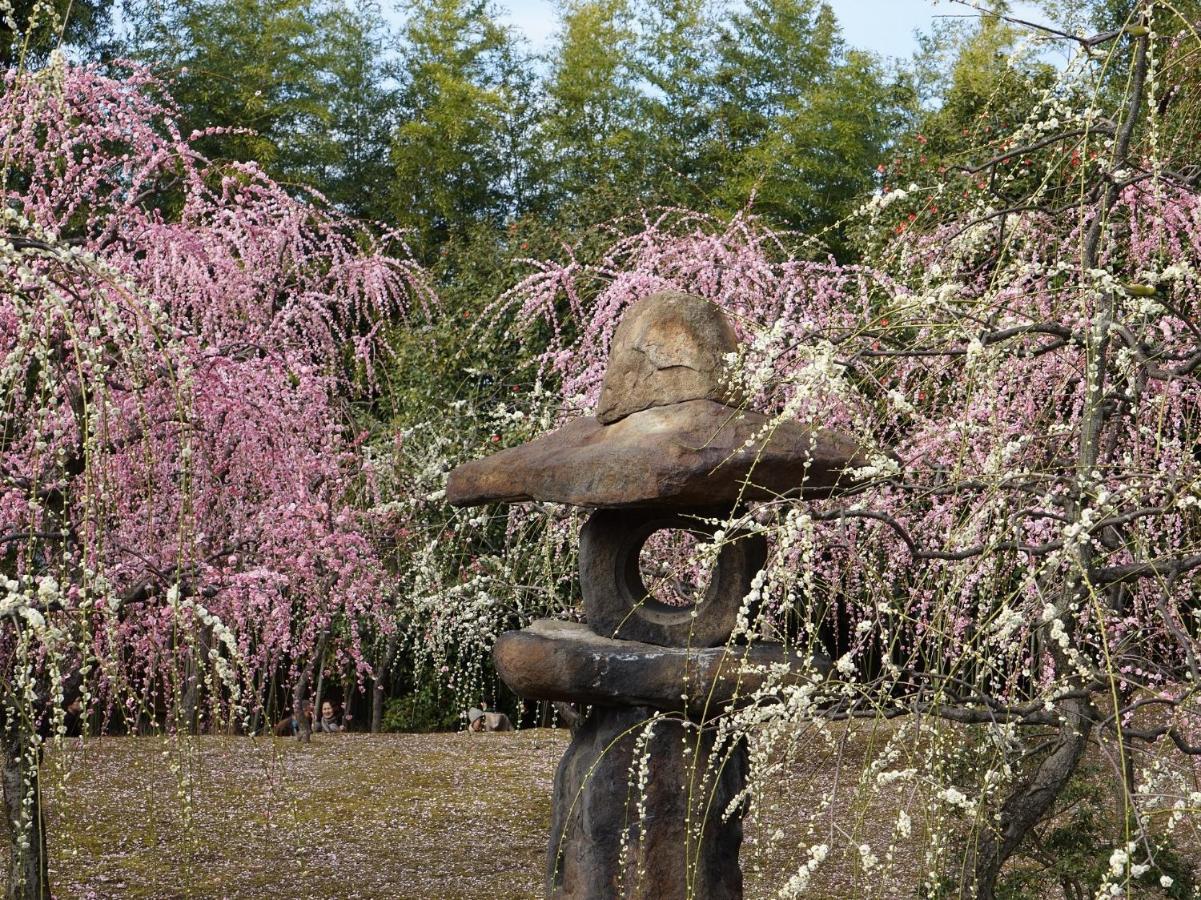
[447,292,866,900]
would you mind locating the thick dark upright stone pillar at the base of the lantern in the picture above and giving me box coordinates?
[546,707,747,900]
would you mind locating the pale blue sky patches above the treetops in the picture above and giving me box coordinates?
[498,0,1042,58]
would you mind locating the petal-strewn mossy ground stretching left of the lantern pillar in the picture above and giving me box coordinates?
[47,731,566,899]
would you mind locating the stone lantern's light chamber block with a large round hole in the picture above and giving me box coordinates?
[580,509,767,646]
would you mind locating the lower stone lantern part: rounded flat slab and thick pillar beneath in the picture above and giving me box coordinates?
[495,619,821,900]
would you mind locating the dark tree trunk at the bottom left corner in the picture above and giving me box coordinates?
[4,725,50,900]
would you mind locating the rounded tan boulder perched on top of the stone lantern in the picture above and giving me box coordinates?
[597,291,737,425]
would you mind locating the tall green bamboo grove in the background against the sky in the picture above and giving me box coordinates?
[114,0,898,254]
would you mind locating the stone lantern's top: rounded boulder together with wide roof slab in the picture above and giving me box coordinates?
[447,292,868,509]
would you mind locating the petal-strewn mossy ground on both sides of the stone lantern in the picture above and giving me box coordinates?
[25,728,1191,900]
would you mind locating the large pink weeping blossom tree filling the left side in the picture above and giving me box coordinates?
[0,60,434,898]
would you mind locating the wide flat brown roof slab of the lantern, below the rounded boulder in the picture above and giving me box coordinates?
[447,400,867,509]
